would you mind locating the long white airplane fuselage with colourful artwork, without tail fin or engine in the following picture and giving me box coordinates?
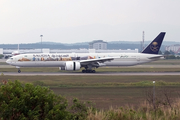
[7,53,163,67]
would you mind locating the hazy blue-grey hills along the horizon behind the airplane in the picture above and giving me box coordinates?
[0,41,180,51]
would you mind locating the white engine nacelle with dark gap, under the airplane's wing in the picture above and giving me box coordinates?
[65,61,81,70]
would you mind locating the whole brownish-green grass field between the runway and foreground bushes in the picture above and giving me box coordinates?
[0,75,180,109]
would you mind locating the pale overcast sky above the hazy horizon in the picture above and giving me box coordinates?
[0,0,180,44]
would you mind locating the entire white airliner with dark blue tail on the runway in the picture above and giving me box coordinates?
[6,32,165,73]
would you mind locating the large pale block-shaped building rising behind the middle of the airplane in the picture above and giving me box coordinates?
[89,40,107,50]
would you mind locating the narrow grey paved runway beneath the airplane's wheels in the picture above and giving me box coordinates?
[0,72,180,76]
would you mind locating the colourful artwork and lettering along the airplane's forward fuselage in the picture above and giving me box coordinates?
[18,54,94,61]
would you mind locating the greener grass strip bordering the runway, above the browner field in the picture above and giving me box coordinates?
[0,75,180,87]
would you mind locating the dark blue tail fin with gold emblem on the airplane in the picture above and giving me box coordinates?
[142,32,166,54]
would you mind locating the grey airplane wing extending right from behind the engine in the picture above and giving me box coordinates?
[80,57,114,67]
